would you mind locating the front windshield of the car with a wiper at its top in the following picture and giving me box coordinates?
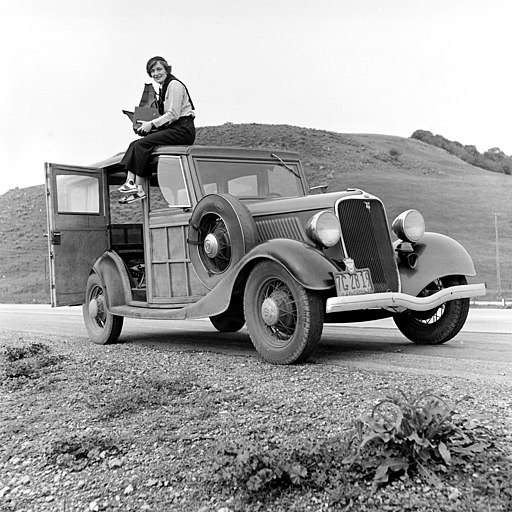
[192,159,306,199]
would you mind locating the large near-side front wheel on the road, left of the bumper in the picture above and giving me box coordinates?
[244,261,324,364]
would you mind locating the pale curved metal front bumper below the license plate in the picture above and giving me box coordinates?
[325,283,485,313]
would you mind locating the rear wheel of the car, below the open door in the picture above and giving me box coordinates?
[82,274,124,345]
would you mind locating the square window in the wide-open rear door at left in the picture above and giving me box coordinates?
[56,174,100,215]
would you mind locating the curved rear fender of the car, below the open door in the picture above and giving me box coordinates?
[93,251,132,308]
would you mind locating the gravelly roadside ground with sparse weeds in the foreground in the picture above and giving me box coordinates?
[0,330,512,512]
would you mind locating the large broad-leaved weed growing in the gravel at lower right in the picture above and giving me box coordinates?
[351,390,488,485]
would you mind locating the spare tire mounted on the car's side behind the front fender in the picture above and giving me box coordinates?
[187,194,257,290]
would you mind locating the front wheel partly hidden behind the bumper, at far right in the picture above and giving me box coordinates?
[393,276,469,345]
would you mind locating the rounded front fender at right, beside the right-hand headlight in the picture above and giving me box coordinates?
[393,233,476,296]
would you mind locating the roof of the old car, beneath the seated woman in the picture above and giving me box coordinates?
[92,145,299,168]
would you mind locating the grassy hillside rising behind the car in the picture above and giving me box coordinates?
[0,123,512,303]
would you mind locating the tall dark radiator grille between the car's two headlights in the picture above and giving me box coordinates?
[338,199,399,292]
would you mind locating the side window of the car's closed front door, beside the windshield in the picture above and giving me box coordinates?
[151,156,191,210]
